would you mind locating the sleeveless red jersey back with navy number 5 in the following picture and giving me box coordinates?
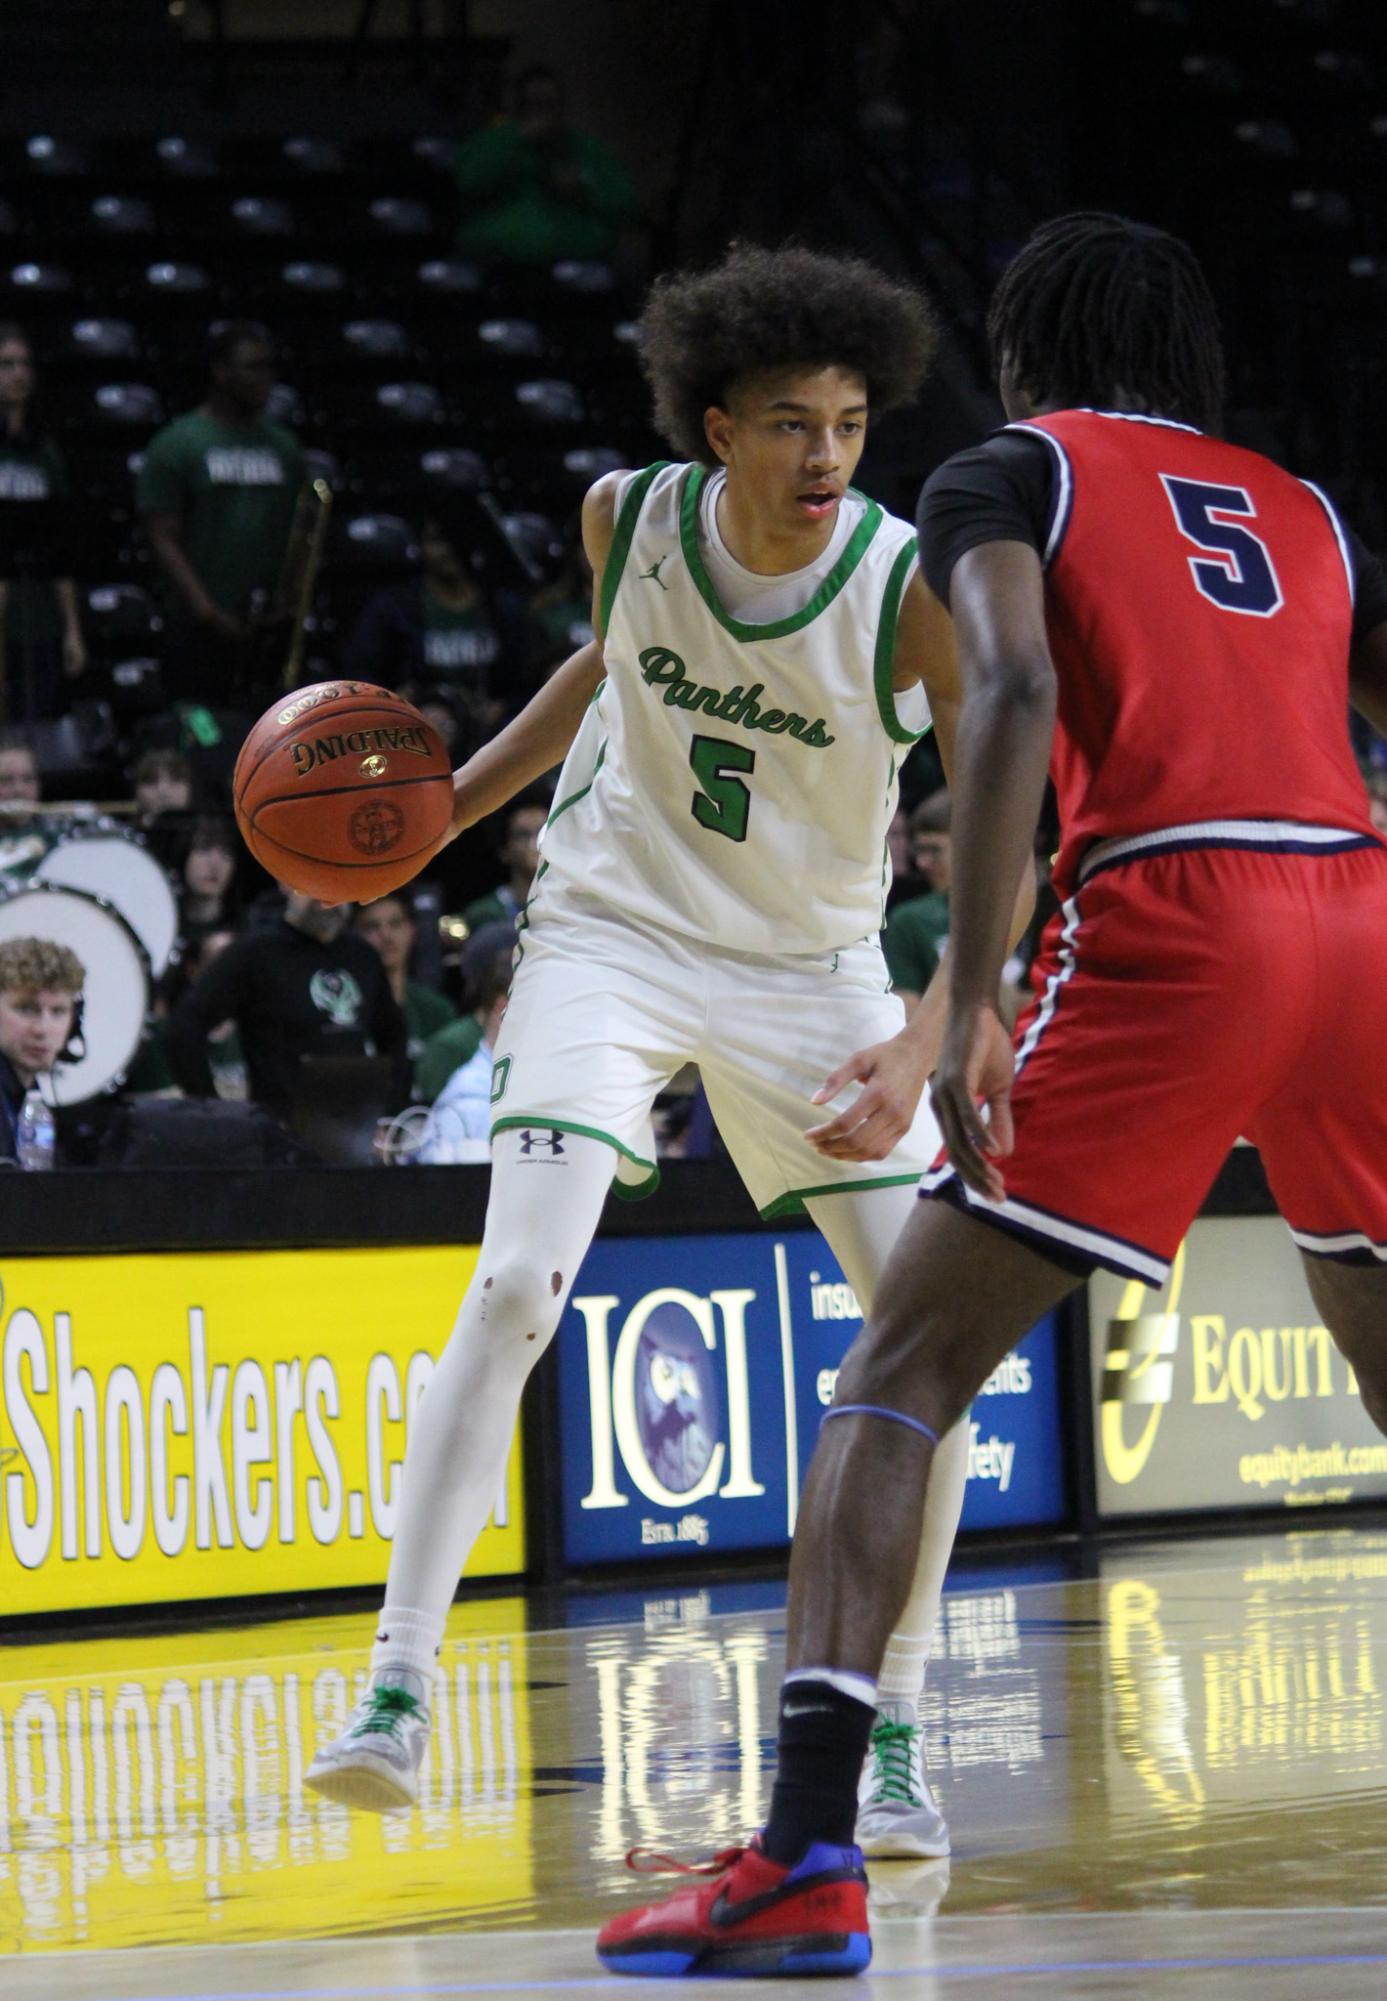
[1013,410,1373,894]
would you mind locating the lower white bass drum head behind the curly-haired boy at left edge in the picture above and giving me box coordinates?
[0,882,150,1105]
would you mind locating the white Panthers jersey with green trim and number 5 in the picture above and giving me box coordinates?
[540,464,929,954]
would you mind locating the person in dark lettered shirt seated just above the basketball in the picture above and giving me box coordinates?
[342,508,500,730]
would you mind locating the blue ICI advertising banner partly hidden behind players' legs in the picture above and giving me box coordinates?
[558,1231,1067,1563]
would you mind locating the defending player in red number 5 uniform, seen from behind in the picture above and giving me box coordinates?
[608,216,1387,1971]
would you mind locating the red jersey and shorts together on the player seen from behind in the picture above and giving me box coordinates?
[904,404,1387,1285]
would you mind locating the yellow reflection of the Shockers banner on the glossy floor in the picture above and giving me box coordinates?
[0,1601,534,1953]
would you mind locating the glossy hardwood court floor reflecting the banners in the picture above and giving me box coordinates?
[0,1529,1387,2001]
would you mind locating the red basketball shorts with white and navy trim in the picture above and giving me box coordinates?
[921,828,1387,1285]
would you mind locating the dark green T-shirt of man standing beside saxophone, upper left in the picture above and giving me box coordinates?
[134,410,304,624]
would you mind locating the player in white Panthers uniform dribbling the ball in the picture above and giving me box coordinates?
[306,248,996,1855]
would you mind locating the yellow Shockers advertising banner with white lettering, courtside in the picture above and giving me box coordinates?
[0,1247,524,1617]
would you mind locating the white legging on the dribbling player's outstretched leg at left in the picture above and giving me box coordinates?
[382,1131,616,1616]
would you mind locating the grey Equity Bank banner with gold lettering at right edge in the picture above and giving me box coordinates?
[1089,1217,1387,1515]
